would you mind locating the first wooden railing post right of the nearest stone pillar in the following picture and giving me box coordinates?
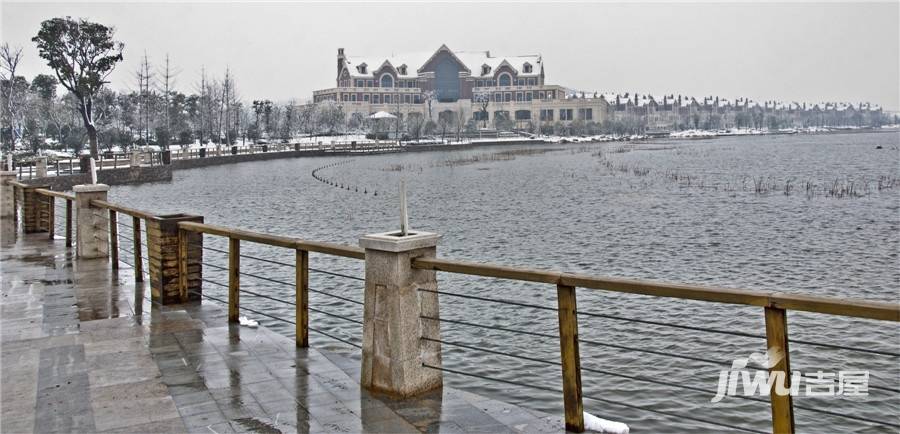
[556,285,584,432]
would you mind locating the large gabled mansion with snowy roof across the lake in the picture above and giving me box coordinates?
[313,45,606,132]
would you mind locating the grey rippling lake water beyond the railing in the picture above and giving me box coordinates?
[110,133,900,432]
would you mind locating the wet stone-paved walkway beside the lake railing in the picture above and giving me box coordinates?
[0,222,563,433]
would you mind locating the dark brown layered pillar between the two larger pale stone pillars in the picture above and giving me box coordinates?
[147,214,203,304]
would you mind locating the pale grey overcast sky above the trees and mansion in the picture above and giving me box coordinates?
[2,1,900,110]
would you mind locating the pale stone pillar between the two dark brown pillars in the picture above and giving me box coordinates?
[72,184,109,259]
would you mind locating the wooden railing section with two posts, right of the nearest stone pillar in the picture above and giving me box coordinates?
[412,258,900,433]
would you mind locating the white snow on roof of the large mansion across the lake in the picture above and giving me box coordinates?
[344,47,542,78]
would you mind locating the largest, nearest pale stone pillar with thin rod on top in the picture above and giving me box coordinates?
[359,232,443,397]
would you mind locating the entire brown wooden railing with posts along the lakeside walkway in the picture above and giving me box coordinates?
[13,187,900,433]
